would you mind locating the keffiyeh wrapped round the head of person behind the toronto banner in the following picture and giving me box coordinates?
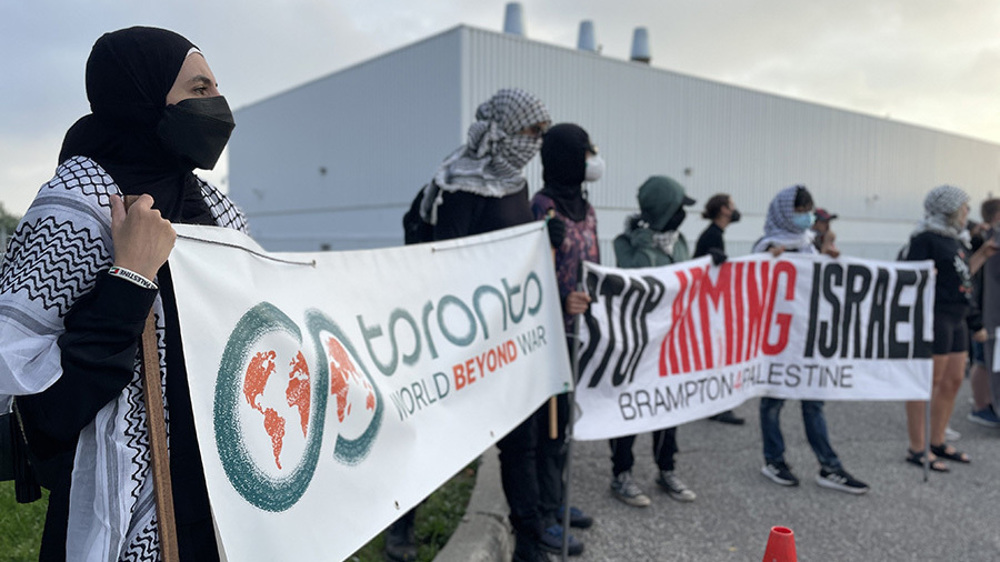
[421,88,552,224]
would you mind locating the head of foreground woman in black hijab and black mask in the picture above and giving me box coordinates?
[59,27,234,224]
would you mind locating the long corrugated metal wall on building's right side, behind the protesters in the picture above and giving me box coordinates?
[463,29,1000,262]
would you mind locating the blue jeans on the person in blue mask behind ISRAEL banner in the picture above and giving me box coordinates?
[760,397,842,470]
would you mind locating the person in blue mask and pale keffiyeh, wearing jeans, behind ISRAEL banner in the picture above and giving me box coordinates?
[753,185,868,494]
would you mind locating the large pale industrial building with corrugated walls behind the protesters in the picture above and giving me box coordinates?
[229,21,1000,263]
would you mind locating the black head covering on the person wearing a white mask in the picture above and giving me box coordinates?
[541,123,594,222]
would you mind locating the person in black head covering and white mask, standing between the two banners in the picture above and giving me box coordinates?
[531,123,604,554]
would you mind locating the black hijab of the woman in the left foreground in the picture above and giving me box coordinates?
[59,27,214,224]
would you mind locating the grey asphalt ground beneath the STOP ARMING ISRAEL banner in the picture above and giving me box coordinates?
[553,384,1000,562]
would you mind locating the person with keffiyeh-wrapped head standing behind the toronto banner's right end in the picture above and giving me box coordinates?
[402,88,565,561]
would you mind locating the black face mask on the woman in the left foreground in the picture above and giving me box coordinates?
[156,96,236,170]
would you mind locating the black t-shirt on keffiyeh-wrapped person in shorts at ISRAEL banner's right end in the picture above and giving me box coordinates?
[903,231,973,313]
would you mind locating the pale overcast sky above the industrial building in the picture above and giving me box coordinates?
[0,0,1000,214]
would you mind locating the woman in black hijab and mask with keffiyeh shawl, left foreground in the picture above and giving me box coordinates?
[0,27,245,560]
